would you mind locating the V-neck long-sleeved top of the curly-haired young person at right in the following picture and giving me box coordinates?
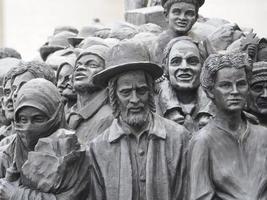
[189,120,267,200]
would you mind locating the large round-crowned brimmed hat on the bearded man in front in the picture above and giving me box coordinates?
[93,40,163,87]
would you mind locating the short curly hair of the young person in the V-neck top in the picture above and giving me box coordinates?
[200,53,252,91]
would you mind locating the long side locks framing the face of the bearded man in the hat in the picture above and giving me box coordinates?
[108,72,156,118]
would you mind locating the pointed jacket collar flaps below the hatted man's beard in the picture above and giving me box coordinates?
[108,114,167,143]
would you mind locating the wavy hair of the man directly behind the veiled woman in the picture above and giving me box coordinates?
[11,61,56,84]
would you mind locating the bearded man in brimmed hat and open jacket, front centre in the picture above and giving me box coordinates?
[88,41,188,200]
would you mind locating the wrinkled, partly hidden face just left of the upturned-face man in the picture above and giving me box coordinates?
[57,64,76,99]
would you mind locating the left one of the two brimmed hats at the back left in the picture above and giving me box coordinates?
[40,31,76,61]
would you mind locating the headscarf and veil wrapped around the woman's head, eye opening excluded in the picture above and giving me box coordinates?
[15,78,65,169]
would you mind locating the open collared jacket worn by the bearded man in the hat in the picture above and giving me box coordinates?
[88,114,188,200]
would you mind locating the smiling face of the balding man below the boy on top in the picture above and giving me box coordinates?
[168,41,201,90]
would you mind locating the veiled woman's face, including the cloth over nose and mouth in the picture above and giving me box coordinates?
[17,106,49,149]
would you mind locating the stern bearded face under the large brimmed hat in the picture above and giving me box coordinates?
[116,71,152,127]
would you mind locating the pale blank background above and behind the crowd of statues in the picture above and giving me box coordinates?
[0,0,267,60]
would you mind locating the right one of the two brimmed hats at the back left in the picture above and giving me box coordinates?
[68,24,108,47]
